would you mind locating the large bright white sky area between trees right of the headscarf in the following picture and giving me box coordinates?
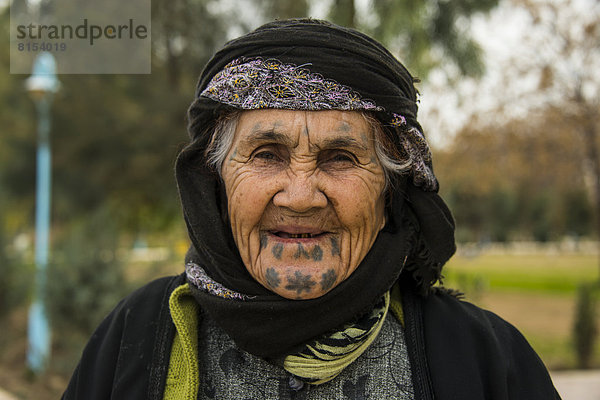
[419,0,600,147]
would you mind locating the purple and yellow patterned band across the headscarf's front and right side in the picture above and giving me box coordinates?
[200,58,438,191]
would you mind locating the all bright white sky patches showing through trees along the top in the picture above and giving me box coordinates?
[8,0,600,147]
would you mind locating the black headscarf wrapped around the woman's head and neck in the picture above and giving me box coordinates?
[176,19,455,358]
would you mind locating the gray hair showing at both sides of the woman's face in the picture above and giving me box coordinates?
[205,111,412,189]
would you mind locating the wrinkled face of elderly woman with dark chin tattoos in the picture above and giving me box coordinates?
[221,110,385,299]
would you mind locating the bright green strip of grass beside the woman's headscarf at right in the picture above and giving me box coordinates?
[444,254,600,295]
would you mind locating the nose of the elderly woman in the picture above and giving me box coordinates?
[273,172,327,213]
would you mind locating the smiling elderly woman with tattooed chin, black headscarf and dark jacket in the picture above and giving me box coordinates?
[64,20,559,400]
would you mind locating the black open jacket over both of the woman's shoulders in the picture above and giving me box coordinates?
[63,275,560,400]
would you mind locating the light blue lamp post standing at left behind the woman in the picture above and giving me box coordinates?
[25,53,59,373]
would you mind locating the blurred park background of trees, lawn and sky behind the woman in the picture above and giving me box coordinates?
[0,0,600,400]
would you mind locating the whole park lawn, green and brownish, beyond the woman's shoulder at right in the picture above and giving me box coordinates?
[444,254,600,369]
